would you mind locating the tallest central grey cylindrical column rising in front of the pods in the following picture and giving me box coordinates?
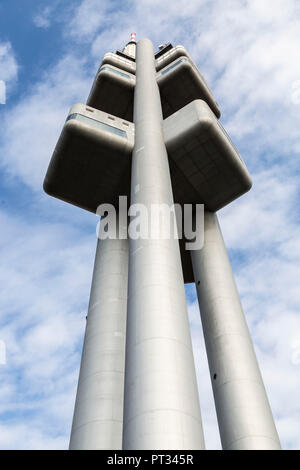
[123,39,204,449]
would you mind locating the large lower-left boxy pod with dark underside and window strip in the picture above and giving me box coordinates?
[44,105,134,212]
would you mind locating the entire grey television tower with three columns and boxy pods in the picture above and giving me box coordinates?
[44,33,280,450]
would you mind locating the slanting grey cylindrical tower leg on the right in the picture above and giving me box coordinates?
[191,212,280,450]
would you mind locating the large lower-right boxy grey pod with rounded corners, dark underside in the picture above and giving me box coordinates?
[164,100,252,211]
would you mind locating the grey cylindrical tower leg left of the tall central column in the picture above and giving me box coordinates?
[70,229,128,450]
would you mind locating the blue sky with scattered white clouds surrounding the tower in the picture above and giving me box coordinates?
[0,0,300,449]
